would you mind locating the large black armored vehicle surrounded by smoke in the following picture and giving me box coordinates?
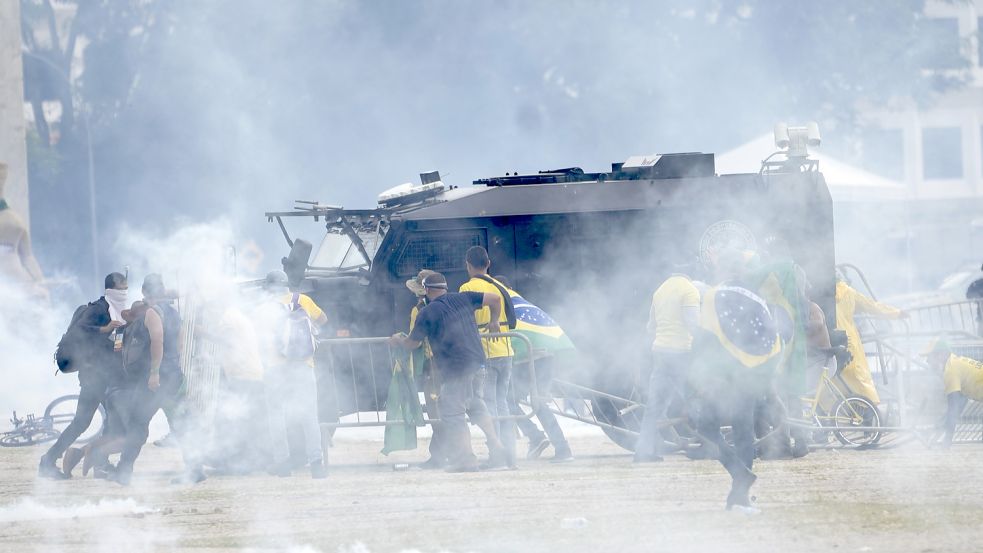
[267,153,835,447]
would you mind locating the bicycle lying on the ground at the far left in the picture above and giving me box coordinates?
[0,394,106,447]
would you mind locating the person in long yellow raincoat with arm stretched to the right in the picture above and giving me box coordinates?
[836,280,908,405]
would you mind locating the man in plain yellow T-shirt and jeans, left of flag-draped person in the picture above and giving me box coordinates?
[635,273,700,463]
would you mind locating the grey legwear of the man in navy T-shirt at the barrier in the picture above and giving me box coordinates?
[437,367,487,466]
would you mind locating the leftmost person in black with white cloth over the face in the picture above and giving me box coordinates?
[38,273,128,480]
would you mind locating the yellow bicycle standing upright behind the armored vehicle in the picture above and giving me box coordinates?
[789,368,883,447]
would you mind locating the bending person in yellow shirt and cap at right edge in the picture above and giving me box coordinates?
[925,339,983,448]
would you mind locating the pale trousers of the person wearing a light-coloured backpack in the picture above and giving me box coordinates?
[265,361,324,463]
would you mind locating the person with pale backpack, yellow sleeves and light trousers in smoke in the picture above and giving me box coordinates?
[259,271,328,479]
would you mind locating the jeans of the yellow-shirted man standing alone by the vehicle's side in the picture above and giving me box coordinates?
[635,352,690,458]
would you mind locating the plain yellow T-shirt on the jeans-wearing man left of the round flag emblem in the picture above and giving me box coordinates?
[648,275,700,351]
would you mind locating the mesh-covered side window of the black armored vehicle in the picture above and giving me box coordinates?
[396,229,486,276]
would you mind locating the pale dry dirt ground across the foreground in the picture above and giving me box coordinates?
[0,420,983,553]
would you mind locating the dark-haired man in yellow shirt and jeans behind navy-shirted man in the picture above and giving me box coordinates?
[459,246,515,468]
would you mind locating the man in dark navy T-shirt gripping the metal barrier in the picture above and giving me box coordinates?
[390,273,502,472]
